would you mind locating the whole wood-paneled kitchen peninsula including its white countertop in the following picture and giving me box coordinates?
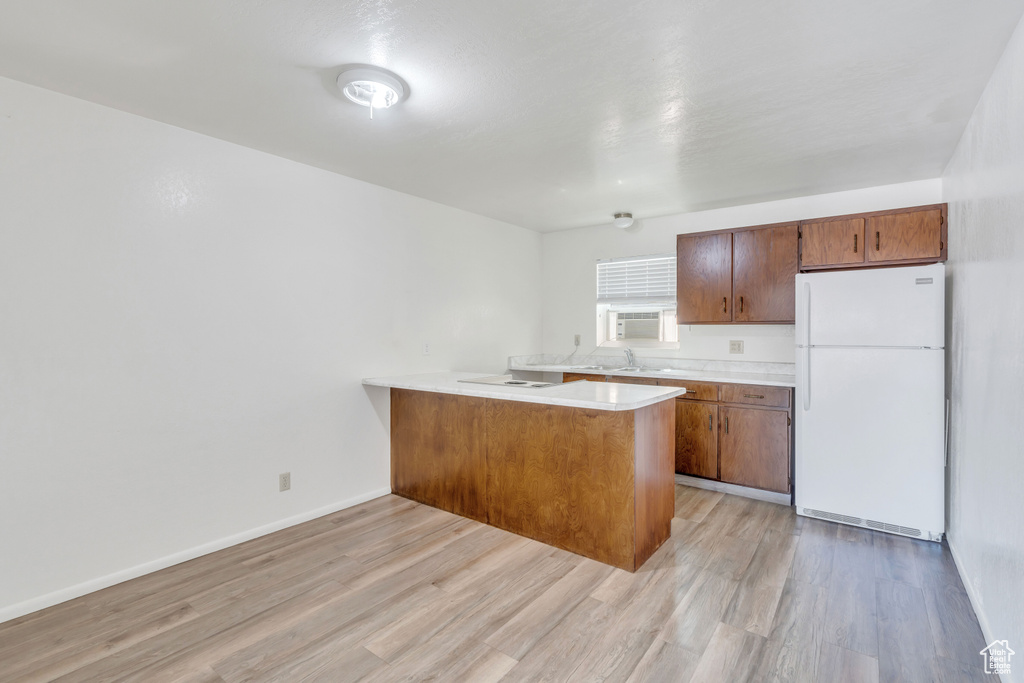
[364,373,685,571]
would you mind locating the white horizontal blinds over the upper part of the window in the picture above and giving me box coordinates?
[597,255,676,303]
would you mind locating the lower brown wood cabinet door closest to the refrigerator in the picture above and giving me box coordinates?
[720,403,790,493]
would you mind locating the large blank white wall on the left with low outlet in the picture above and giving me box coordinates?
[0,79,541,621]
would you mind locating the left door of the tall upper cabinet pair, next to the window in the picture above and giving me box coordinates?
[676,232,732,325]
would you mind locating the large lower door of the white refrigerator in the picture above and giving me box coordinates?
[794,348,945,533]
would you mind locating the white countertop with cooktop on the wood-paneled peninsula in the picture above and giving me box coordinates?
[362,373,686,411]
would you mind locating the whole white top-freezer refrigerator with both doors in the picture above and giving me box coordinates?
[794,263,945,541]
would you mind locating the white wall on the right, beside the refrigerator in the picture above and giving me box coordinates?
[943,13,1024,681]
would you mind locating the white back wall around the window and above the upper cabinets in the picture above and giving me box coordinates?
[544,178,942,362]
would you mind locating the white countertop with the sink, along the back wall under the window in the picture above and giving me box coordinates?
[509,356,797,387]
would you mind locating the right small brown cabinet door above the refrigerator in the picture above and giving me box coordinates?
[867,209,943,261]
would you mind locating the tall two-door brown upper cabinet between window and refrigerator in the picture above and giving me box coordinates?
[676,223,799,325]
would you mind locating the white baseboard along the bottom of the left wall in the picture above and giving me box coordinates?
[0,486,391,624]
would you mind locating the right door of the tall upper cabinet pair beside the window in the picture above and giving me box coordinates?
[732,223,799,323]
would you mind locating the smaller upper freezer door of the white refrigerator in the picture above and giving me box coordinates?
[797,263,945,348]
